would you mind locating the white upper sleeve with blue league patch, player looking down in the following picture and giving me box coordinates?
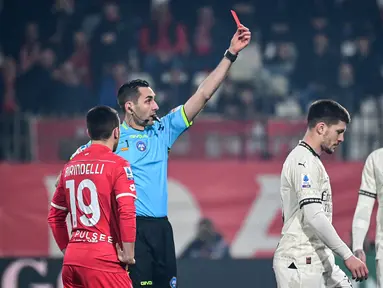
[291,161,322,209]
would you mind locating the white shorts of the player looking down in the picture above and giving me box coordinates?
[273,260,353,288]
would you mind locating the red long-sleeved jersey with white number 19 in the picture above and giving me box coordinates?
[48,144,136,273]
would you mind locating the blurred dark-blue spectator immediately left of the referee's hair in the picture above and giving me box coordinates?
[99,62,128,108]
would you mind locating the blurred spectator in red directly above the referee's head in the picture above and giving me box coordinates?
[140,3,188,80]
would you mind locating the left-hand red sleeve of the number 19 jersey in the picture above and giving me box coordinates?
[48,172,69,250]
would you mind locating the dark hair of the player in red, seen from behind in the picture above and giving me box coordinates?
[86,106,120,140]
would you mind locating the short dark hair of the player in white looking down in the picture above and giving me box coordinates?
[307,99,351,128]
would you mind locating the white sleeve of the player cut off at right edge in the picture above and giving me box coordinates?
[352,152,377,251]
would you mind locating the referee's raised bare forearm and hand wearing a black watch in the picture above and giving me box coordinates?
[185,25,251,121]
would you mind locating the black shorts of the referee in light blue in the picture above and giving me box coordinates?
[129,216,177,288]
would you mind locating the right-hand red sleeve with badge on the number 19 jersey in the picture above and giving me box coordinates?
[113,160,137,243]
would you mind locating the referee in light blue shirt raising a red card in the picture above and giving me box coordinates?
[68,25,251,288]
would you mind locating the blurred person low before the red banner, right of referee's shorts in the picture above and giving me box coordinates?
[180,218,230,260]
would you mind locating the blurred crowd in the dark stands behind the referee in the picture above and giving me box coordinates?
[0,0,383,119]
